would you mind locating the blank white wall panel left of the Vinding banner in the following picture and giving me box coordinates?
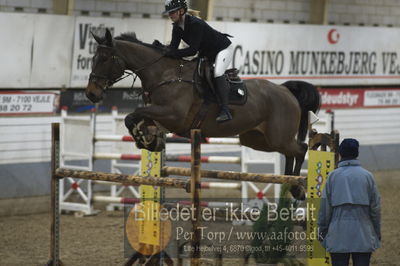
[0,12,75,89]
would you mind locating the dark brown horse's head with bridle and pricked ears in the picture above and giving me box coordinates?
[86,29,125,103]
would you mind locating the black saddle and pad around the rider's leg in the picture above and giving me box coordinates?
[193,58,247,105]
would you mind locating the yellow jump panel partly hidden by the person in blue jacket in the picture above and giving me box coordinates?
[307,150,335,266]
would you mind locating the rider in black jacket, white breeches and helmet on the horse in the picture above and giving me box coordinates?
[164,0,233,122]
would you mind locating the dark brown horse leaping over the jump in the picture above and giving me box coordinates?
[86,29,320,199]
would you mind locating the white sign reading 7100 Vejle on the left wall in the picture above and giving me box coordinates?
[0,92,59,115]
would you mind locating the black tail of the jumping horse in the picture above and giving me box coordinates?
[282,80,321,142]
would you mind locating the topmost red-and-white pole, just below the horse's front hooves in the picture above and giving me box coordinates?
[93,152,241,164]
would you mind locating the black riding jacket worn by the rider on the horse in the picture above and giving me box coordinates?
[168,14,232,61]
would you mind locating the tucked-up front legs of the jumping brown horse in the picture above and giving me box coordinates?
[125,105,180,151]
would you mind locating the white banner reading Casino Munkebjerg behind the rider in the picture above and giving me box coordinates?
[226,23,400,85]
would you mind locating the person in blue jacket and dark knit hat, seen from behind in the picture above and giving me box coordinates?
[318,138,381,266]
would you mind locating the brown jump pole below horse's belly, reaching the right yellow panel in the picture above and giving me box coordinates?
[163,166,307,187]
